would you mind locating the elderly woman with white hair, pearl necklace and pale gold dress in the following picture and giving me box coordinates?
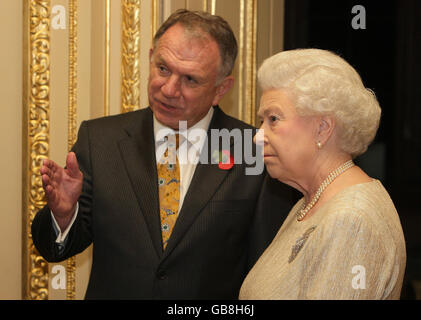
[240,49,406,299]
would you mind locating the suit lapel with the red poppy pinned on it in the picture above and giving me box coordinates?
[163,107,233,258]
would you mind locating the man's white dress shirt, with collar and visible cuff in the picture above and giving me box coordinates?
[51,108,214,244]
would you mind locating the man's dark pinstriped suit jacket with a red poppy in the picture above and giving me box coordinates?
[32,107,292,299]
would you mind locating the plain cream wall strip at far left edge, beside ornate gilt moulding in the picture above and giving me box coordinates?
[0,0,23,299]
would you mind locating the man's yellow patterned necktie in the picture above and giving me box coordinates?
[157,134,180,249]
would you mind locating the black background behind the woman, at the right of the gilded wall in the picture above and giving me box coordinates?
[284,0,421,299]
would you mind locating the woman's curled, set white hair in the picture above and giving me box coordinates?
[258,49,381,158]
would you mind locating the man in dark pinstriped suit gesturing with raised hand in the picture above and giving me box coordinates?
[32,10,291,299]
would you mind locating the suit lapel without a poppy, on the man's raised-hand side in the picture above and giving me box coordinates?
[119,109,162,257]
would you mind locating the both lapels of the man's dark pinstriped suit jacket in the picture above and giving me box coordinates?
[119,107,244,259]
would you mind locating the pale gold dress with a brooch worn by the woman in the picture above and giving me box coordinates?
[239,180,406,300]
